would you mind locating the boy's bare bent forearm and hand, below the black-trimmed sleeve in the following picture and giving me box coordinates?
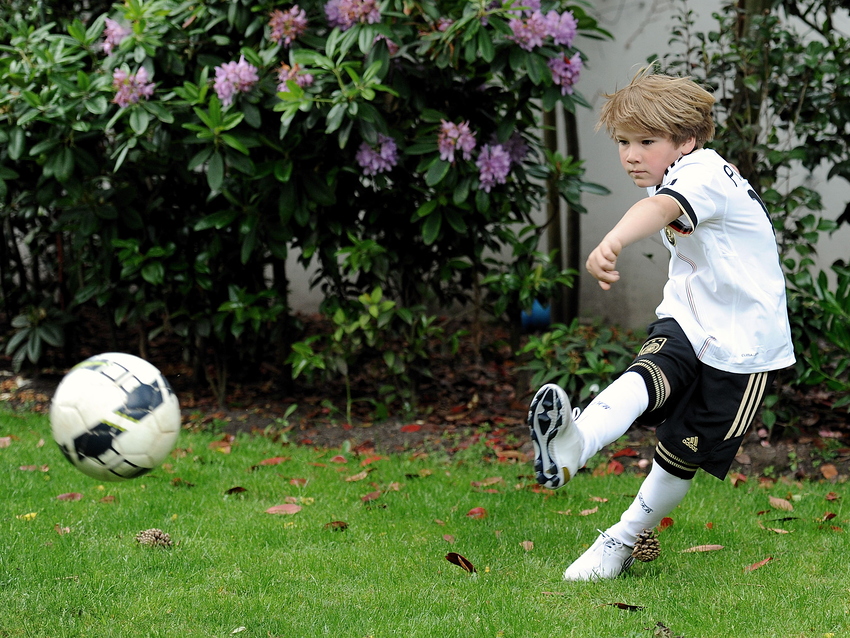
[585,195,682,290]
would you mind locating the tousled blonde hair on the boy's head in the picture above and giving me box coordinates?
[596,66,714,148]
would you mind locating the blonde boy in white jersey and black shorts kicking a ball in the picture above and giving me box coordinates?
[528,71,794,581]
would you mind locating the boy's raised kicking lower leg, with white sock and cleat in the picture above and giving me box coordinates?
[528,372,649,489]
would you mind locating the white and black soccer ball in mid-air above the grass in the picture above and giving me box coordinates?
[50,352,180,481]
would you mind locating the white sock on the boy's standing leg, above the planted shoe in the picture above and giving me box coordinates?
[607,463,691,545]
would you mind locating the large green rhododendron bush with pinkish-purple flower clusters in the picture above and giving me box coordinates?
[0,0,606,400]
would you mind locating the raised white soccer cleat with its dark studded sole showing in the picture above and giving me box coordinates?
[528,383,583,489]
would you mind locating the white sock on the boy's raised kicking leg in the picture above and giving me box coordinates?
[576,372,649,467]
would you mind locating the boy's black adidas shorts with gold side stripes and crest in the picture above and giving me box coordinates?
[628,318,776,480]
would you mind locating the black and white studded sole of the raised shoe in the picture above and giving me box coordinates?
[528,383,572,489]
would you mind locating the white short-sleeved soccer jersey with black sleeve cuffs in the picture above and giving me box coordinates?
[647,149,794,373]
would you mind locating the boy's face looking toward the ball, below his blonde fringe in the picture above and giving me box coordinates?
[614,129,696,188]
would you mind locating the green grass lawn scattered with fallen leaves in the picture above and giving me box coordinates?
[0,410,850,638]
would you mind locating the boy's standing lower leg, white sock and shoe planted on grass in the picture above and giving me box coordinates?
[564,464,691,580]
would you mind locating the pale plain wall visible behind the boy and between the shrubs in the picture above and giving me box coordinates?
[287,0,850,328]
